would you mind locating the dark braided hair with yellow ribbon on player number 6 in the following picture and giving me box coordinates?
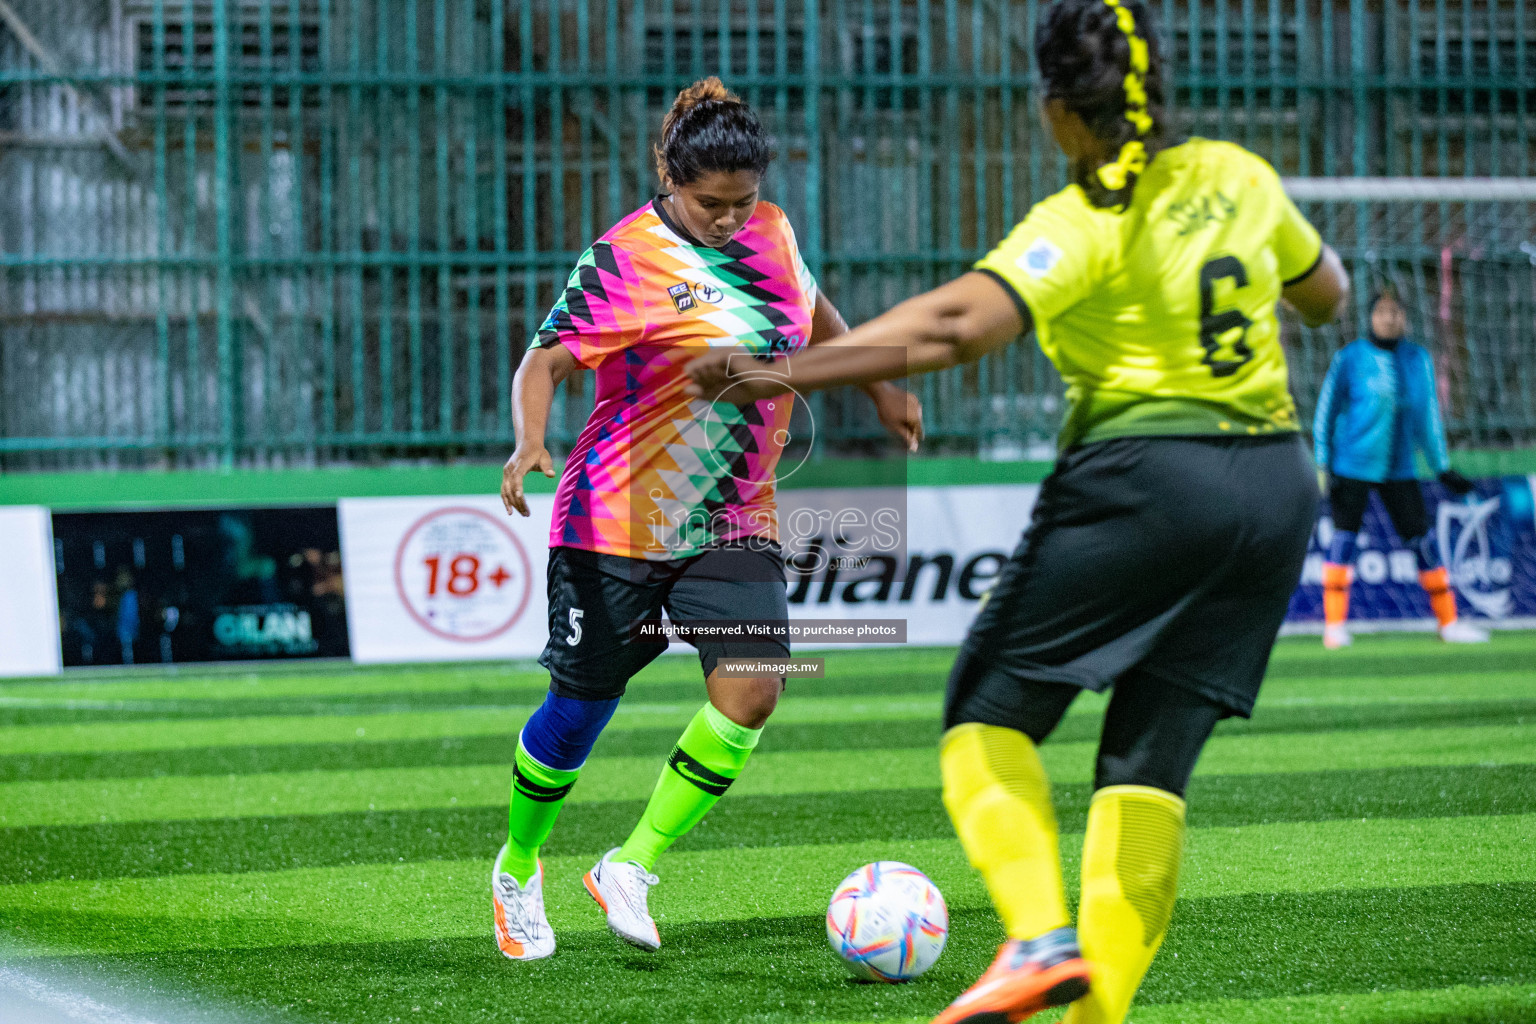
[1035,0,1167,207]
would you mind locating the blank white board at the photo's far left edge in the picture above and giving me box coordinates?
[0,505,60,676]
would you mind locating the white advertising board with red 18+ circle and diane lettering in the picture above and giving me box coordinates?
[338,485,1038,663]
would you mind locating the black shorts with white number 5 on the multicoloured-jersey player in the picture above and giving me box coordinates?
[539,542,790,700]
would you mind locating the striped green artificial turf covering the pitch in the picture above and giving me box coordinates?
[0,634,1536,1024]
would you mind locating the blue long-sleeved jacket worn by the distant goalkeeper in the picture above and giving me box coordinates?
[1312,338,1450,484]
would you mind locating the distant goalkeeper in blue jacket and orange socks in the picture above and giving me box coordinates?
[1312,292,1488,649]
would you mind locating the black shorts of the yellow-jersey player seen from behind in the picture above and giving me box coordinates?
[945,434,1318,729]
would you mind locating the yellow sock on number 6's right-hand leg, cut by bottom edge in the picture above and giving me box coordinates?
[1061,786,1184,1024]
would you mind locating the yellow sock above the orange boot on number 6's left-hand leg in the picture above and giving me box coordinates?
[940,723,1071,938]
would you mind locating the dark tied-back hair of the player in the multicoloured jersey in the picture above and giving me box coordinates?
[656,75,773,189]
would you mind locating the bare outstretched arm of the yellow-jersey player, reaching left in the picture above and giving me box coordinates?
[685,272,1031,399]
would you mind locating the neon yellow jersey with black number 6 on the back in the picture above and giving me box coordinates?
[975,138,1322,448]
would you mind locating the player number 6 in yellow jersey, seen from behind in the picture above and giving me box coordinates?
[690,0,1347,1024]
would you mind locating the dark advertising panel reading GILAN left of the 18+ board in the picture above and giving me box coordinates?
[54,507,349,668]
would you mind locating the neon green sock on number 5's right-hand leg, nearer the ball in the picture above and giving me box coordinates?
[613,705,763,870]
